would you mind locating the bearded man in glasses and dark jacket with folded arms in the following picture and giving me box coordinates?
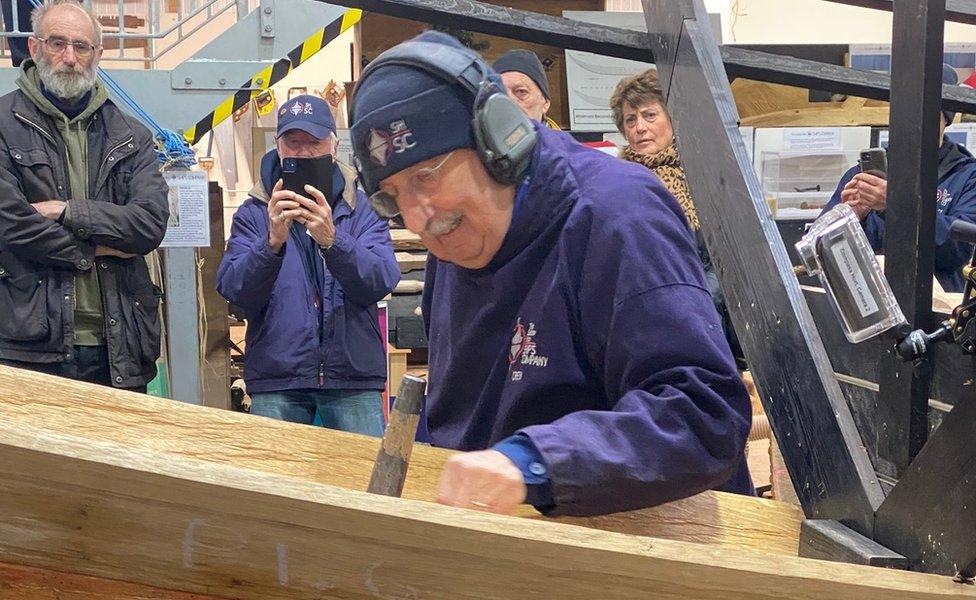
[0,0,169,390]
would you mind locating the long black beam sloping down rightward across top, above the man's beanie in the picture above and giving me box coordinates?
[319,0,976,114]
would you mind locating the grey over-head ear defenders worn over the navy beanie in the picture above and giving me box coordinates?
[349,41,538,194]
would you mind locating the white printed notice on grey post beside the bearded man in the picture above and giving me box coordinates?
[160,171,210,248]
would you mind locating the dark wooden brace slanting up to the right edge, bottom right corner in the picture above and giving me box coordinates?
[875,376,976,575]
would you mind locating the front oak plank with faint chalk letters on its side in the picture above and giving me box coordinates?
[0,421,976,600]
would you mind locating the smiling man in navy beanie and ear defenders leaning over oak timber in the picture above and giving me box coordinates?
[351,32,754,515]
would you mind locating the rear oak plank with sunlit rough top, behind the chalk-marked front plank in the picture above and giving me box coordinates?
[0,366,803,560]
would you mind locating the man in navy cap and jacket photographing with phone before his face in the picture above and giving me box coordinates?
[217,95,400,436]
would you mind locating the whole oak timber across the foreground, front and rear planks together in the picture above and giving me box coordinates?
[0,367,976,600]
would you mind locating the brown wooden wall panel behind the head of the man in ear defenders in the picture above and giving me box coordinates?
[362,0,604,128]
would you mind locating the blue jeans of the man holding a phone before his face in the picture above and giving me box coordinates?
[251,390,384,437]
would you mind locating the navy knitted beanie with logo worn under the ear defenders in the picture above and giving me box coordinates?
[350,31,501,191]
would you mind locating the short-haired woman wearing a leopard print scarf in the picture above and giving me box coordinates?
[610,69,745,368]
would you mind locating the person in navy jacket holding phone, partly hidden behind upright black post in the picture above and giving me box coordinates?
[824,65,976,292]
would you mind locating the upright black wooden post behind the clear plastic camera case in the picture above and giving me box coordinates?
[875,0,945,478]
